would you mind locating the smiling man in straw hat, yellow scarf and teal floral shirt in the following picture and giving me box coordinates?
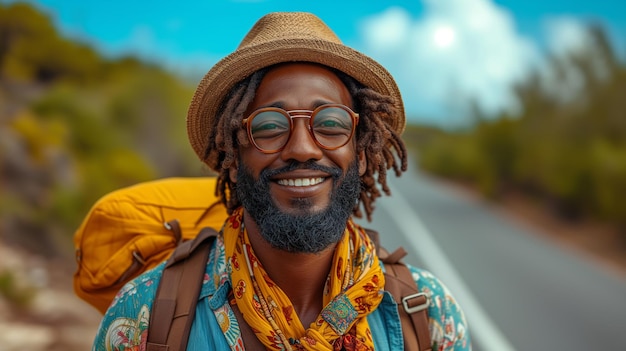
[94,13,471,350]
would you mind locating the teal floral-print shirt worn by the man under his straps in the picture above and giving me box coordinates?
[92,237,471,351]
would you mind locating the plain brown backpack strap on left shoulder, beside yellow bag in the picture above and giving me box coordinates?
[146,222,217,351]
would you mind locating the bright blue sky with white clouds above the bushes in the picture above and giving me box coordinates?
[9,0,626,125]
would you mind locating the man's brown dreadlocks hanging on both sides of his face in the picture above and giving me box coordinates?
[204,64,407,221]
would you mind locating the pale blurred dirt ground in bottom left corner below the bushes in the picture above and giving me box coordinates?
[0,242,100,351]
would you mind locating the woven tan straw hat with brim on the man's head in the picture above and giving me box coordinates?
[187,12,405,169]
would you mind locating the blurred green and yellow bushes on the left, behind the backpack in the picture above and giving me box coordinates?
[0,3,201,256]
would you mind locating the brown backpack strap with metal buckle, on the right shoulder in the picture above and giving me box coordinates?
[365,229,432,351]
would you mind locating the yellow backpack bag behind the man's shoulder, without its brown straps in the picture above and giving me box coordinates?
[74,177,227,313]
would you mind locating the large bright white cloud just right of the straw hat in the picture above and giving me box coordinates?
[361,0,538,124]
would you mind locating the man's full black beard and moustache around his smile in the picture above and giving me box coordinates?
[235,161,361,253]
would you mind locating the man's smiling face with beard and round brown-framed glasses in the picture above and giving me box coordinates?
[230,63,365,255]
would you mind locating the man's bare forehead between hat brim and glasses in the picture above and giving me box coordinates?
[252,62,352,108]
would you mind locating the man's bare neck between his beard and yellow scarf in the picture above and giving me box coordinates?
[244,216,335,328]
